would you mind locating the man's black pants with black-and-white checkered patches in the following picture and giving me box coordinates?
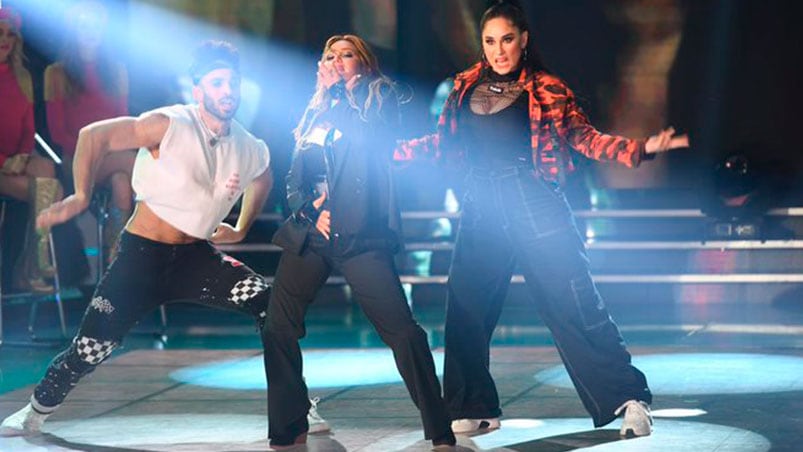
[32,232,270,413]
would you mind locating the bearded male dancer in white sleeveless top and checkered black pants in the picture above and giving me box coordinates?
[0,41,328,436]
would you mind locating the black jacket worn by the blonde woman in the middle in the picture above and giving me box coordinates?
[273,79,401,256]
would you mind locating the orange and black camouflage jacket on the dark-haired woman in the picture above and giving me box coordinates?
[394,63,645,181]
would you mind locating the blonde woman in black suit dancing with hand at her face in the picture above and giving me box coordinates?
[264,35,455,449]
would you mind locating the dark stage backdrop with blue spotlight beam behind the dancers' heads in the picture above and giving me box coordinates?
[3,0,803,208]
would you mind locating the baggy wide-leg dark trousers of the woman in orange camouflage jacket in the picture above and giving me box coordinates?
[444,167,652,427]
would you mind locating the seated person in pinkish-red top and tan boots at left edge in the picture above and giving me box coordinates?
[0,8,62,292]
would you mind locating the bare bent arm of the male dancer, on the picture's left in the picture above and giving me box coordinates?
[36,114,170,228]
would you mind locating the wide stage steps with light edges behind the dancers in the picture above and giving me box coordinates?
[215,208,803,303]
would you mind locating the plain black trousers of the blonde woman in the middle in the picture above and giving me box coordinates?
[264,232,451,445]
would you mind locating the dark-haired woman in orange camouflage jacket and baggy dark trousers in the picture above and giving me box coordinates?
[396,1,688,436]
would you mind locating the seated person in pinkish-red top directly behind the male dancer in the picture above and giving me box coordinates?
[45,1,136,260]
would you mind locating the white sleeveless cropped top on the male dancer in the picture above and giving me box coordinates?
[131,105,270,239]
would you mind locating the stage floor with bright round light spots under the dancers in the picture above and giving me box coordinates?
[0,298,803,452]
